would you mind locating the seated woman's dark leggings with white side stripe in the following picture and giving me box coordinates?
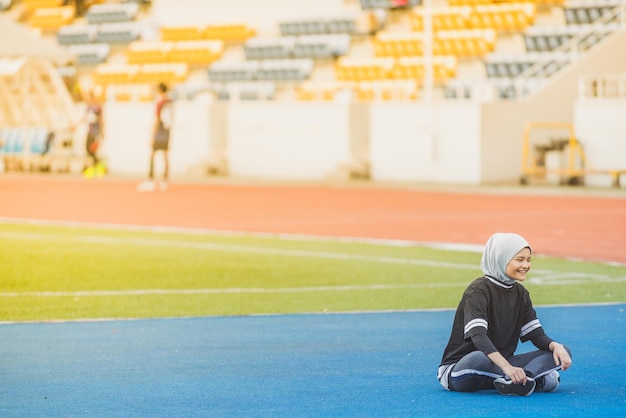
[448,347,571,392]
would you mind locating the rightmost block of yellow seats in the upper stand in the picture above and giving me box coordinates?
[470,2,537,32]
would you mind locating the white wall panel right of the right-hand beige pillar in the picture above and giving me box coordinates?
[370,102,481,184]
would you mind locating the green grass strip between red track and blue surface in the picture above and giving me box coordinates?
[0,223,626,321]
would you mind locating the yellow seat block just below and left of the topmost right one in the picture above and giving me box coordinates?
[433,29,496,57]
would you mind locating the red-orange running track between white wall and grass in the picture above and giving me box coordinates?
[0,174,626,263]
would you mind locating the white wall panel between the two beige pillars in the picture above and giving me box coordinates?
[227,102,351,180]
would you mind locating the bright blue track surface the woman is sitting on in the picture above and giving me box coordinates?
[0,304,626,417]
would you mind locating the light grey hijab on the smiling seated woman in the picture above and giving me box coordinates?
[480,232,532,285]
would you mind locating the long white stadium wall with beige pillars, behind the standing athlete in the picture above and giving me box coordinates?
[102,101,481,184]
